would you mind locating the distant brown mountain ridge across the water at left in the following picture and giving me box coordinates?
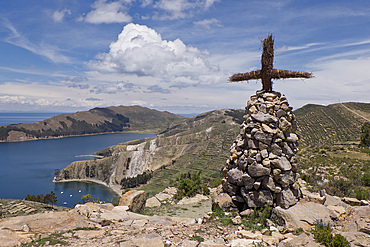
[0,106,185,141]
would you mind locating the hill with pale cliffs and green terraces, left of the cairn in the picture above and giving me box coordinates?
[56,110,244,196]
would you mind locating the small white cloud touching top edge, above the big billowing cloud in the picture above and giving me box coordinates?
[80,0,132,24]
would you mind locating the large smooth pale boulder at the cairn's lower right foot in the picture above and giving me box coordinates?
[272,202,332,231]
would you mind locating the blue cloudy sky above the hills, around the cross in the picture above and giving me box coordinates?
[0,0,370,113]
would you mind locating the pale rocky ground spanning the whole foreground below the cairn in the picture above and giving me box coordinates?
[0,180,370,247]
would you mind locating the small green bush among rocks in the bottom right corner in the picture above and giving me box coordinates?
[313,220,351,247]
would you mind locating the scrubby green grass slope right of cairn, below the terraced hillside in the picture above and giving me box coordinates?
[298,145,370,200]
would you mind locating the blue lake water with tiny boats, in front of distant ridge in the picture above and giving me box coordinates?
[0,113,154,207]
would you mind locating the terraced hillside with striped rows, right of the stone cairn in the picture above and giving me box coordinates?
[294,102,370,145]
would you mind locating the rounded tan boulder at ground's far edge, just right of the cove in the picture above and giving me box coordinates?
[118,190,146,213]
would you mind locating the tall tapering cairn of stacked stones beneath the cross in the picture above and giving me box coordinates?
[222,91,301,210]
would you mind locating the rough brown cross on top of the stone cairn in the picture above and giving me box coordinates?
[229,34,313,92]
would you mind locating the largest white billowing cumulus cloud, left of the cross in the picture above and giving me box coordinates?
[88,23,220,84]
